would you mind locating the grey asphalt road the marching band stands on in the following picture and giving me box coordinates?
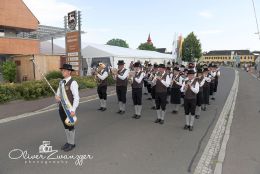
[0,68,234,174]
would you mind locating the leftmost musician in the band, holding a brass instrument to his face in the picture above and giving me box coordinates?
[95,63,108,111]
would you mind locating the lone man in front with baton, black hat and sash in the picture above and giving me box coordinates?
[55,64,79,152]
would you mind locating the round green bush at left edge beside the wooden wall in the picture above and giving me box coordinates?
[2,61,16,83]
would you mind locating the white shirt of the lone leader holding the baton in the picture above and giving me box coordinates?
[56,76,79,112]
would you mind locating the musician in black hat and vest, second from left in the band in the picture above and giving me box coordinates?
[116,60,129,114]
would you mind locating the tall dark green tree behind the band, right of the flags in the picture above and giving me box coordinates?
[182,32,202,62]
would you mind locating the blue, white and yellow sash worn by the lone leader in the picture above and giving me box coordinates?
[59,81,77,126]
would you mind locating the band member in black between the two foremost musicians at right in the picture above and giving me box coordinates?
[171,67,183,114]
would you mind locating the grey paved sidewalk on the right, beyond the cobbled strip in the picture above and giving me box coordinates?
[222,70,260,174]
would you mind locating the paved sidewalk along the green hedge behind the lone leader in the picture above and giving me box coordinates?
[0,86,115,119]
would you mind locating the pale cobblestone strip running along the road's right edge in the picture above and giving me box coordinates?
[194,70,239,174]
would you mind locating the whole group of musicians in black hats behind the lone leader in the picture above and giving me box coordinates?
[95,60,220,131]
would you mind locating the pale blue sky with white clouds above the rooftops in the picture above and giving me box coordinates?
[24,0,260,51]
